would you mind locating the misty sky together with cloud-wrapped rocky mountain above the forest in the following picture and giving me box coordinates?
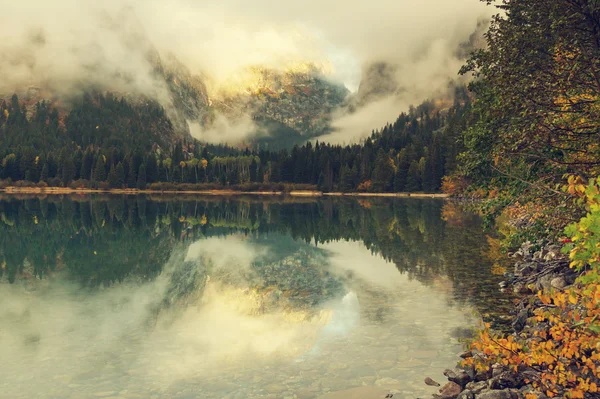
[0,0,489,148]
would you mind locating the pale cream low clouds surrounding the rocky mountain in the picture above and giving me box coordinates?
[0,0,492,142]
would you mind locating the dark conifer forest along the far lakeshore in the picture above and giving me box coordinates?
[0,87,471,192]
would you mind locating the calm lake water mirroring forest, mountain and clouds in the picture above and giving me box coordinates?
[0,196,510,399]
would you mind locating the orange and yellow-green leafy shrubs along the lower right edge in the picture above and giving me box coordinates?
[465,177,600,399]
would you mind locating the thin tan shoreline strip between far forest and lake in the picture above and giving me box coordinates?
[0,187,449,198]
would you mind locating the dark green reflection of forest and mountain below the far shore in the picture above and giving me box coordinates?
[0,196,510,318]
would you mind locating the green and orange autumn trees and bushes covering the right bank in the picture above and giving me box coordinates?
[444,0,600,399]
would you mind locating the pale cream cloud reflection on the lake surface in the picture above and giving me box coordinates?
[0,235,478,398]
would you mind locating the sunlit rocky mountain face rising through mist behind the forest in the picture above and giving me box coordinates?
[7,56,348,148]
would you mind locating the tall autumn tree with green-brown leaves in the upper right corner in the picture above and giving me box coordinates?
[461,0,600,184]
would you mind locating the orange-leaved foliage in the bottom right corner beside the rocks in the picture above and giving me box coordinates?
[465,284,600,399]
